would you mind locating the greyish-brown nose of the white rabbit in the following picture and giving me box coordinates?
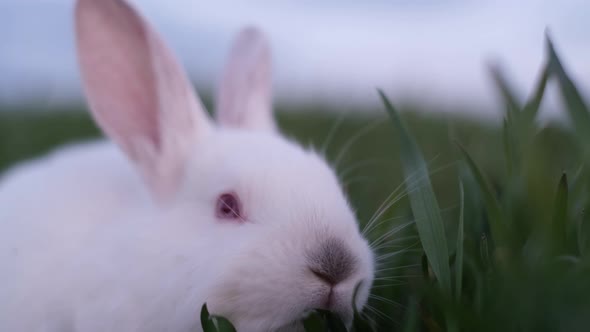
[309,239,357,286]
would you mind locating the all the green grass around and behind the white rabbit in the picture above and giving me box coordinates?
[0,35,590,331]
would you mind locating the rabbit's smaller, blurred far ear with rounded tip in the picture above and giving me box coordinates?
[216,27,276,131]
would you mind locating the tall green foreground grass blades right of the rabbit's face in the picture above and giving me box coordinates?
[374,38,590,331]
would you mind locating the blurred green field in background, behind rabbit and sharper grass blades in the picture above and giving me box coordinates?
[0,103,576,233]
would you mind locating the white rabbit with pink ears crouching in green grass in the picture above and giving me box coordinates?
[0,0,374,332]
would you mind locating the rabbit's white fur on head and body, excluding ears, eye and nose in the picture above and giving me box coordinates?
[0,0,374,332]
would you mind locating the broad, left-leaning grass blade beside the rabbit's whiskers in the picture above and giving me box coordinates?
[379,90,451,295]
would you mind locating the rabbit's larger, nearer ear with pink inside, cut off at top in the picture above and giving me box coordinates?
[76,0,210,199]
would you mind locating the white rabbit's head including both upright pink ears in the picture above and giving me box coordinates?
[76,0,373,331]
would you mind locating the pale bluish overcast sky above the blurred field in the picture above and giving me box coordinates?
[0,0,590,119]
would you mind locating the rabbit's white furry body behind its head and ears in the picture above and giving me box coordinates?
[0,142,182,331]
